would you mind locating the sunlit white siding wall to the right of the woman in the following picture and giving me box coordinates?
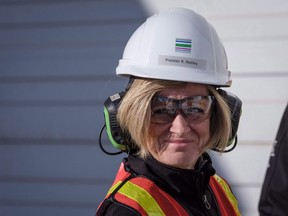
[142,0,288,216]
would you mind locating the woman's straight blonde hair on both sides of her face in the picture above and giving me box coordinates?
[117,79,231,158]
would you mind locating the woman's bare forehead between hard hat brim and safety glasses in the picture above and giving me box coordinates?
[157,83,209,99]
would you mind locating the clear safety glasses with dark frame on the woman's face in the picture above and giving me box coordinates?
[151,96,214,124]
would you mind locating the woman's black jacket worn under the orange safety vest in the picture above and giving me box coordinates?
[96,153,220,216]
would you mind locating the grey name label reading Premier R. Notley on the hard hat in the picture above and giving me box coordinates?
[158,55,206,70]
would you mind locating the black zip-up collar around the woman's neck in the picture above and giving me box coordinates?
[126,153,215,199]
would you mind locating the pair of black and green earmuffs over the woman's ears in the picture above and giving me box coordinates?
[99,78,242,155]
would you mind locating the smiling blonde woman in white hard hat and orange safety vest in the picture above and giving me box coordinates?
[96,8,240,216]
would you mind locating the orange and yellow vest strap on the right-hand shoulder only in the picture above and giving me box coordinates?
[209,175,241,216]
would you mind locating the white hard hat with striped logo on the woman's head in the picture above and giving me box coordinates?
[116,8,231,86]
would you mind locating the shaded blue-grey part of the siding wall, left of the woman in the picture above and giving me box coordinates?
[0,0,146,216]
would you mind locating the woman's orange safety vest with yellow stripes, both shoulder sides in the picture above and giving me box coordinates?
[100,164,240,216]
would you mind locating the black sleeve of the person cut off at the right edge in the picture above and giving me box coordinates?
[258,105,288,216]
